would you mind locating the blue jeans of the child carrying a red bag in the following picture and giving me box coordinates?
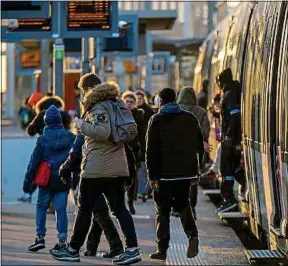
[36,188,69,239]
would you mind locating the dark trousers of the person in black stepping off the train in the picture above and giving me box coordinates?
[220,141,241,201]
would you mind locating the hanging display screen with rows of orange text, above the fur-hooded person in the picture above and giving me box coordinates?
[67,0,111,31]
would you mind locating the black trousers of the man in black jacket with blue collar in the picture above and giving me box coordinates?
[154,180,198,252]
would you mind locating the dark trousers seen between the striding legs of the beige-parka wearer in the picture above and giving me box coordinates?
[86,194,123,251]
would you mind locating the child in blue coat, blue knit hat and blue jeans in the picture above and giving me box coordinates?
[23,105,75,252]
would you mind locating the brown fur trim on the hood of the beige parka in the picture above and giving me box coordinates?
[80,82,120,114]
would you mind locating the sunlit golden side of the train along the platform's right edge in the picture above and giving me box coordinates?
[194,1,288,256]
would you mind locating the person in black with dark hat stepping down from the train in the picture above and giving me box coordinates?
[217,68,245,212]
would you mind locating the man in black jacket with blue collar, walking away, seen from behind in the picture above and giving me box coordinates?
[146,88,204,260]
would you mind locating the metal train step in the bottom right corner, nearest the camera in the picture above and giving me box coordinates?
[244,249,288,265]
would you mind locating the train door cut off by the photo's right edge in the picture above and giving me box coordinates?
[276,3,288,243]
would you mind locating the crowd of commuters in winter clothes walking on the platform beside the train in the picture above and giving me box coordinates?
[19,69,245,265]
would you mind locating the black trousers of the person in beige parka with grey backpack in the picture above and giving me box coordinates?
[70,177,138,250]
